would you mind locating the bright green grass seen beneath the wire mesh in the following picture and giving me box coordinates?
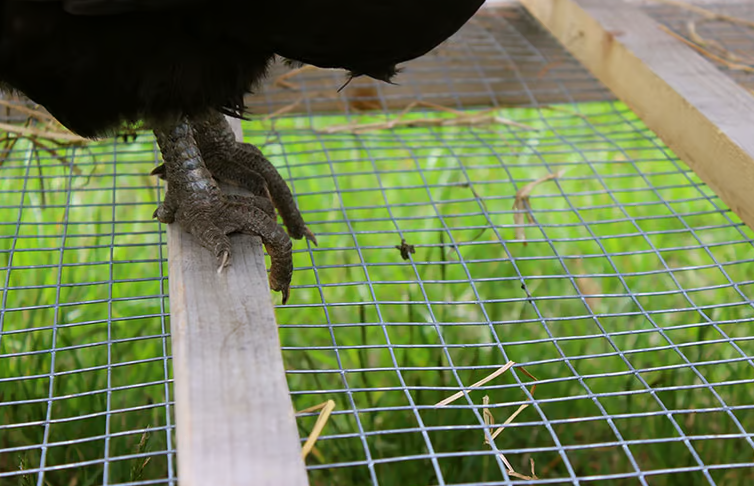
[0,103,754,486]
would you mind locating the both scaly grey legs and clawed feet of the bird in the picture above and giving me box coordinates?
[152,114,308,304]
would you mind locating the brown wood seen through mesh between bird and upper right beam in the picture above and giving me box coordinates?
[246,6,614,115]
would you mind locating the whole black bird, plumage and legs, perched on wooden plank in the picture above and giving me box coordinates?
[0,0,484,302]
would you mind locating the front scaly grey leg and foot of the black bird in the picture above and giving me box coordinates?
[154,116,293,303]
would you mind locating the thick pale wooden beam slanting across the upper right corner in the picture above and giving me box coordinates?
[522,0,754,228]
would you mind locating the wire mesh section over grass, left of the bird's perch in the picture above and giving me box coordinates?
[0,141,174,486]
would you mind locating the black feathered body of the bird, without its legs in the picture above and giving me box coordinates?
[0,0,483,137]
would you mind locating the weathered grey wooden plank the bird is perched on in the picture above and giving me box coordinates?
[168,117,309,486]
